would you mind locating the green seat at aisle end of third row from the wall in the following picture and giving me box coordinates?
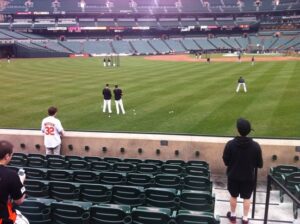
[183,176,212,192]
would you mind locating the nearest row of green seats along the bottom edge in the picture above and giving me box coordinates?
[18,198,220,224]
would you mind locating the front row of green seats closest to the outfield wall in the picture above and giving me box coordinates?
[12,153,209,168]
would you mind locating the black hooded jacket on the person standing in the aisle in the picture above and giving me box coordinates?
[223,136,263,181]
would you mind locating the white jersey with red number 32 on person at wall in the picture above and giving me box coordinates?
[41,116,64,148]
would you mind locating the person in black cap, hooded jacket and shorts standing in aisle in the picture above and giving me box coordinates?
[223,118,263,224]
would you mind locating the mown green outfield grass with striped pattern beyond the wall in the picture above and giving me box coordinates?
[0,57,300,137]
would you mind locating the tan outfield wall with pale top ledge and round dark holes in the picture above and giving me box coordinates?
[0,129,300,179]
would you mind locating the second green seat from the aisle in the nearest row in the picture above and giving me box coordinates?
[131,206,174,224]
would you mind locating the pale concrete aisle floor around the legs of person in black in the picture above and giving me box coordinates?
[212,176,300,224]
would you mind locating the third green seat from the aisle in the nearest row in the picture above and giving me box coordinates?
[90,204,131,224]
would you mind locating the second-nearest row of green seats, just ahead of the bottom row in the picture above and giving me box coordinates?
[25,180,215,212]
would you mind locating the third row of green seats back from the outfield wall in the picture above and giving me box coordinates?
[18,167,212,192]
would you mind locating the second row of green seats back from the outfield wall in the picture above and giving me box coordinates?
[9,157,210,177]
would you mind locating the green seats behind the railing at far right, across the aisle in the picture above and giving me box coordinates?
[270,165,300,219]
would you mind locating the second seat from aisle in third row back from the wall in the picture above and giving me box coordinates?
[154,174,182,189]
